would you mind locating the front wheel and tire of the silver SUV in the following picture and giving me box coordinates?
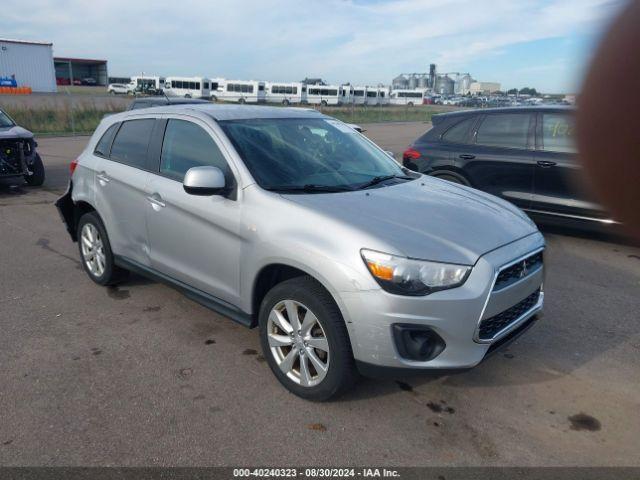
[259,276,358,402]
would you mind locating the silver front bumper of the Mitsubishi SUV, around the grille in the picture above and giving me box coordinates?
[341,233,544,370]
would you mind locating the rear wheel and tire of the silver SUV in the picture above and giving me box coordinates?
[77,212,129,286]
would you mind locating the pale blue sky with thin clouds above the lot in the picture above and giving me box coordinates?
[0,0,623,93]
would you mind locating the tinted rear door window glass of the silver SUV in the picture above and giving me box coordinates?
[111,118,155,169]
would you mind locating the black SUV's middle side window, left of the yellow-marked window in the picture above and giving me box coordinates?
[476,113,531,149]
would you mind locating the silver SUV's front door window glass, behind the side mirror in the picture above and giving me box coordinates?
[160,120,232,183]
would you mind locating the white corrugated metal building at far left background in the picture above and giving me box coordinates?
[0,38,56,92]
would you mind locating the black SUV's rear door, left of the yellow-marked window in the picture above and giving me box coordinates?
[462,112,535,208]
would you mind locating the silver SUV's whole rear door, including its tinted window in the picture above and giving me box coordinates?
[96,118,156,265]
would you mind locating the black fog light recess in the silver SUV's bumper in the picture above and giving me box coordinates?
[391,323,447,362]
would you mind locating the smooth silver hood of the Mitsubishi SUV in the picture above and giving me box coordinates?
[284,177,538,265]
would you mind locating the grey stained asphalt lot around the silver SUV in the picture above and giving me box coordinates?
[0,124,640,466]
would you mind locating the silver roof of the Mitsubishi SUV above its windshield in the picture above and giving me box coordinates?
[127,102,325,120]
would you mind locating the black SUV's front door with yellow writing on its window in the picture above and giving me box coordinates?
[531,111,607,218]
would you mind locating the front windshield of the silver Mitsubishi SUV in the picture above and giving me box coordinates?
[220,118,405,192]
